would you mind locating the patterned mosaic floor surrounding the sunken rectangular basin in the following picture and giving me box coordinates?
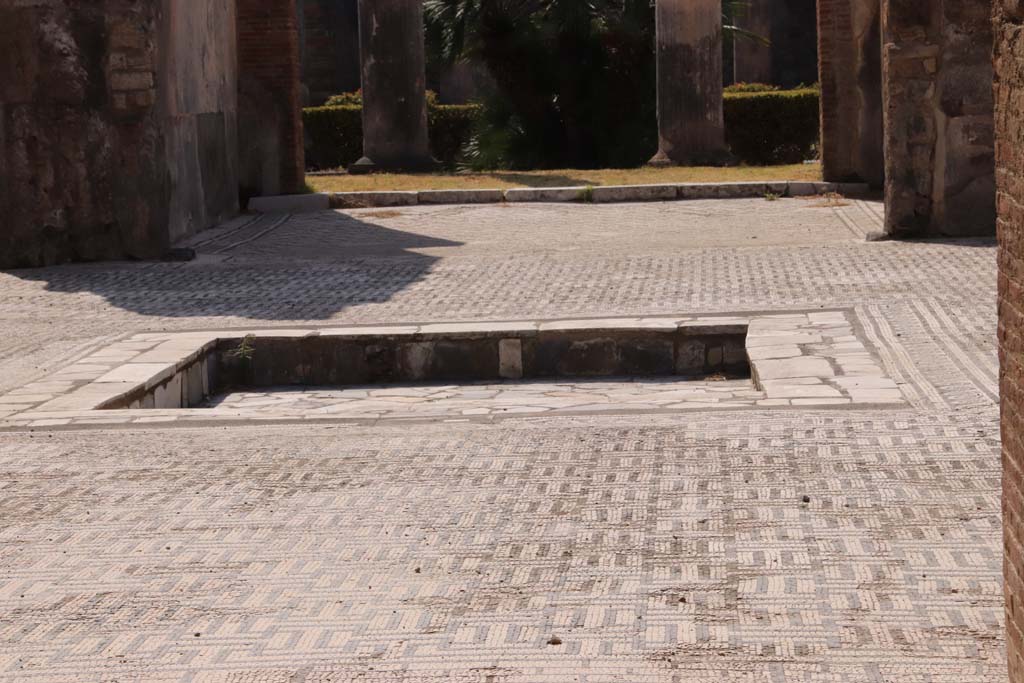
[0,200,1006,683]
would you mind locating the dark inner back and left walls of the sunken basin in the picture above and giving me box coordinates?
[100,319,751,410]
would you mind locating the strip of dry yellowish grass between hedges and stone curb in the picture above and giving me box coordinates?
[306,164,821,193]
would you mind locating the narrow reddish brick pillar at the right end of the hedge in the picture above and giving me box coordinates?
[818,0,885,187]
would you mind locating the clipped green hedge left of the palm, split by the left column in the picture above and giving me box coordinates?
[302,104,480,169]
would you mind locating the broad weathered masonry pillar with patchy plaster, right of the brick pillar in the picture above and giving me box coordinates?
[883,0,995,237]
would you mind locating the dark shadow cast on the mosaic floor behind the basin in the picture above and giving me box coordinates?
[6,212,461,325]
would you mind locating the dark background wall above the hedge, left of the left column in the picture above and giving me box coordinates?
[298,0,359,106]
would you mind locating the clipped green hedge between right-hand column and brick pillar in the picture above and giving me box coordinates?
[725,88,820,165]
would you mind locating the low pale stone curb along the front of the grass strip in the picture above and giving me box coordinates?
[249,181,869,213]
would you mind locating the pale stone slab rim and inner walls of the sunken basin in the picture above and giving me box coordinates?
[0,310,906,431]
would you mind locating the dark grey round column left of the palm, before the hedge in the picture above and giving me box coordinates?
[348,0,437,173]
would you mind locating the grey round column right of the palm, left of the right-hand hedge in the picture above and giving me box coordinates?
[650,0,729,166]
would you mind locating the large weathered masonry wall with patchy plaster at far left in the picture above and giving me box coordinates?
[0,0,237,267]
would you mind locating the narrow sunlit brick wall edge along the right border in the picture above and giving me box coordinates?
[994,0,1024,681]
